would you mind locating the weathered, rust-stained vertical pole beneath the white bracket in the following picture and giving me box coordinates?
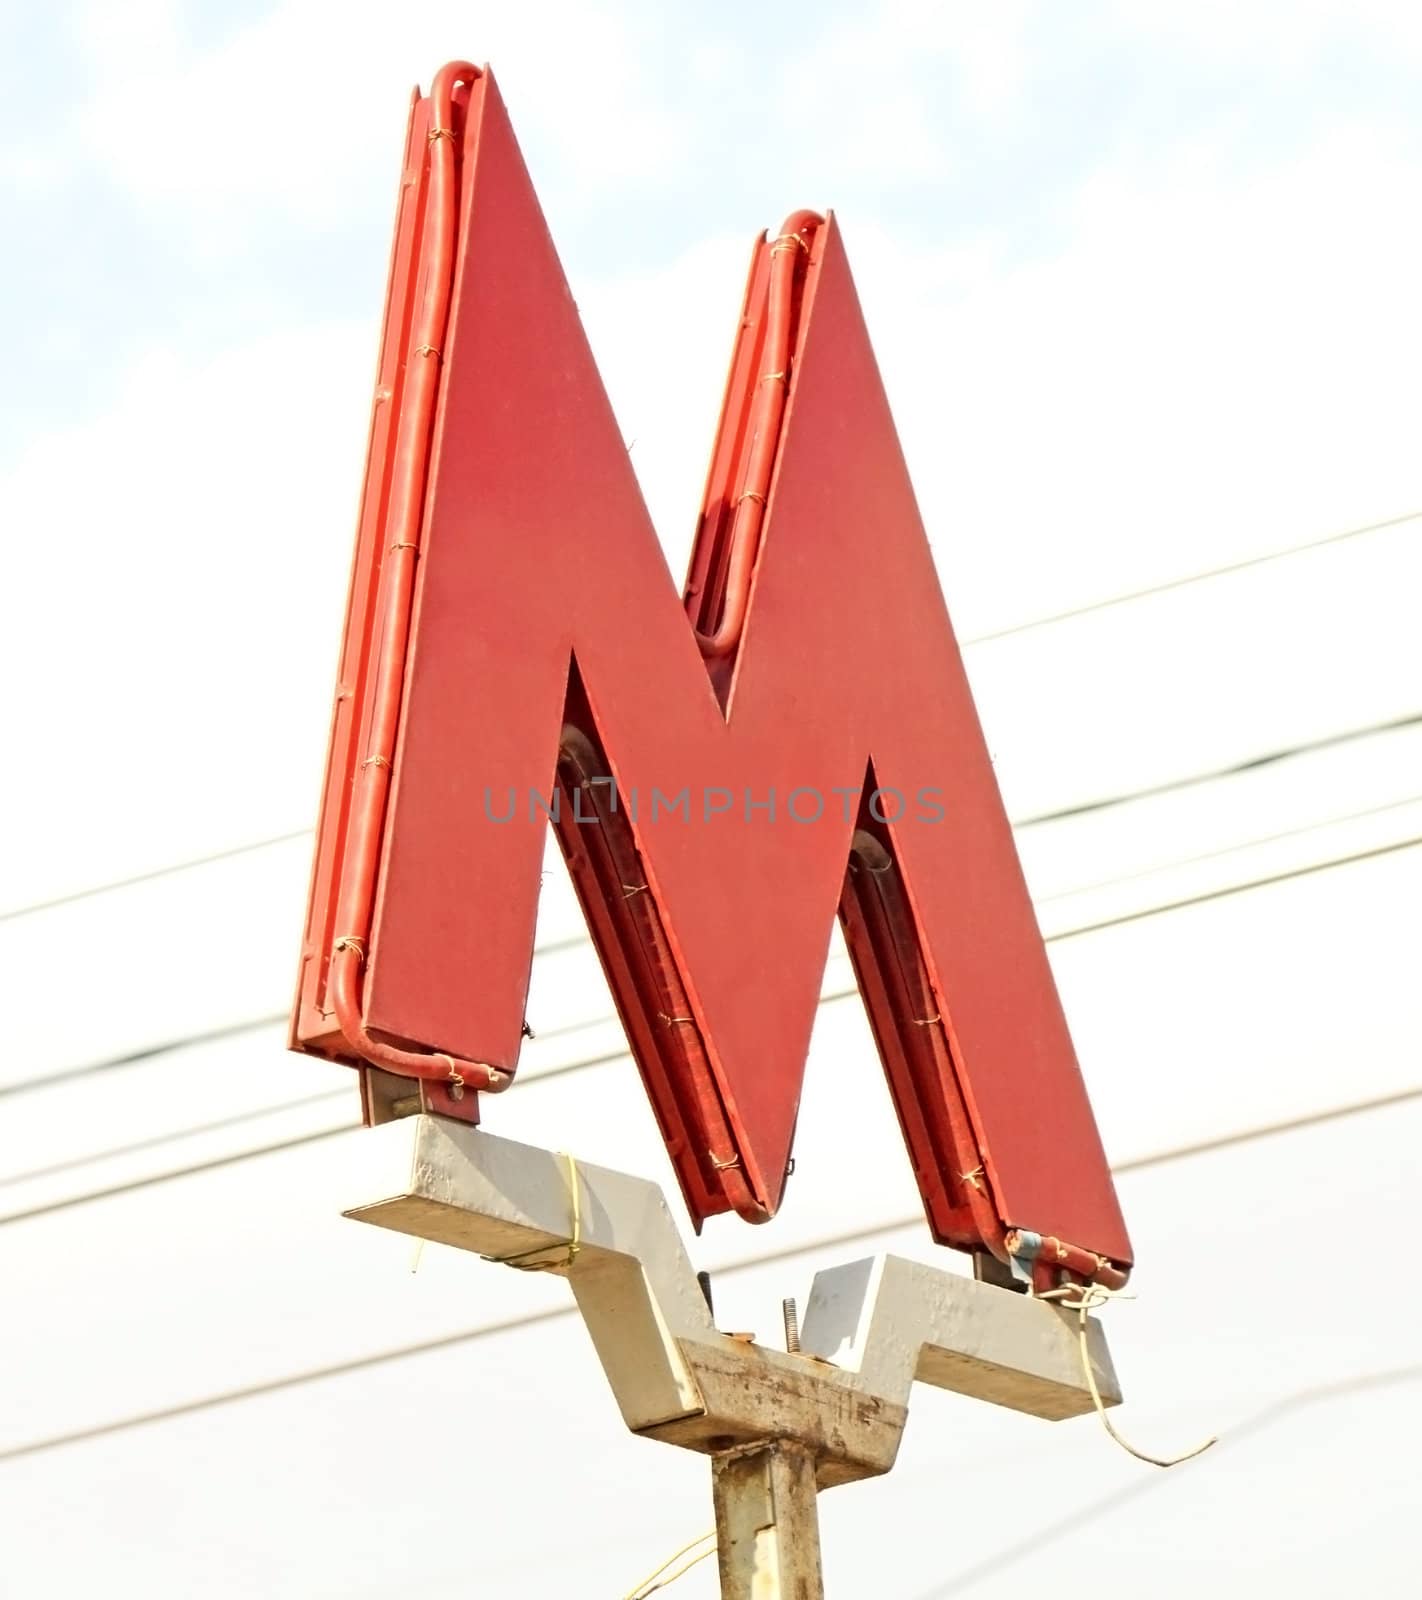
[712,1440,824,1600]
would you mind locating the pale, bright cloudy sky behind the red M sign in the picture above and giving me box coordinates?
[0,0,1422,1600]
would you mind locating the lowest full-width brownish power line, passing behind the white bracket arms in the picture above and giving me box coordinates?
[0,1085,1422,1465]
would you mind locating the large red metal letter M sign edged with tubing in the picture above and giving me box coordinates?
[294,67,1129,1282]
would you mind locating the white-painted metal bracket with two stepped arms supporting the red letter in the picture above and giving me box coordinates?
[346,1115,1120,1486]
